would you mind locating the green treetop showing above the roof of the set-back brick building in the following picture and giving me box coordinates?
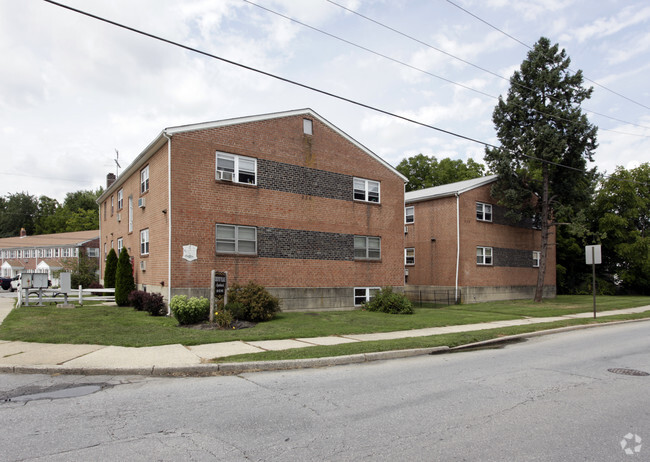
[397,154,485,192]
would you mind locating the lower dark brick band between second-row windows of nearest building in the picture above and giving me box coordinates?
[257,228,354,261]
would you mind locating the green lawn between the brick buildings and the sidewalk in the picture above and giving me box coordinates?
[0,296,650,351]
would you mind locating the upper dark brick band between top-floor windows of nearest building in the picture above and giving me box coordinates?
[257,159,354,201]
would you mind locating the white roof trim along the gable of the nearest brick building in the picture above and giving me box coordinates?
[97,108,408,204]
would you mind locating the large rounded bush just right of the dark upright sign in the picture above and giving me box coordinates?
[228,281,280,322]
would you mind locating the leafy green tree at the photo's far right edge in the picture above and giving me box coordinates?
[593,162,650,295]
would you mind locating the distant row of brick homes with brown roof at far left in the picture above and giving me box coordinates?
[0,229,100,285]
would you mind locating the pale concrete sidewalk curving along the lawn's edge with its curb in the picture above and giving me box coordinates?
[0,298,650,376]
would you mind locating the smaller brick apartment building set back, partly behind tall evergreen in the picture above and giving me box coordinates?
[404,175,556,303]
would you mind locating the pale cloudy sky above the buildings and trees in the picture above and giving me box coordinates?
[0,0,650,201]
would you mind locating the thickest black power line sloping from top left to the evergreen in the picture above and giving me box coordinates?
[43,0,643,184]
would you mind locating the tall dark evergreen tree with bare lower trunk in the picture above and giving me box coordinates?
[485,37,597,302]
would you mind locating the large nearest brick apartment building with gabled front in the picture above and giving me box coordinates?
[98,109,406,310]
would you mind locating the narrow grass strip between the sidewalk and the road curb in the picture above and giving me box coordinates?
[212,312,650,363]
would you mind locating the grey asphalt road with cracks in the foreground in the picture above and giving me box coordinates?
[0,322,650,461]
